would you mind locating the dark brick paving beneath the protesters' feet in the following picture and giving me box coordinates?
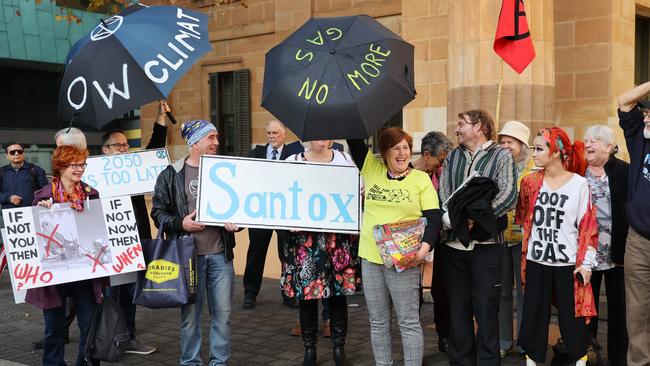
[0,272,607,366]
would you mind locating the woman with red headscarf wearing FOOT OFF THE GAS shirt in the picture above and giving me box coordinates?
[517,127,598,365]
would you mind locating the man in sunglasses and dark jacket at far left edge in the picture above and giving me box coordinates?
[0,142,48,209]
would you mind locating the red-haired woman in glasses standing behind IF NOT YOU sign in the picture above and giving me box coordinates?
[25,146,102,366]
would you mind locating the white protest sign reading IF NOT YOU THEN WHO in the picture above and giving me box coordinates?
[2,197,145,291]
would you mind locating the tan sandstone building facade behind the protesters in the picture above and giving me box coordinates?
[142,0,650,161]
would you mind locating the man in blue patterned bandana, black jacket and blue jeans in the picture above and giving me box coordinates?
[151,120,239,365]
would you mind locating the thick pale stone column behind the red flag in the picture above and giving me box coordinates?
[447,0,555,143]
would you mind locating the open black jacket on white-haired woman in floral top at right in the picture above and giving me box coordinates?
[605,155,630,264]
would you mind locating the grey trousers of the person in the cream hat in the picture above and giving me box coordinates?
[499,243,524,350]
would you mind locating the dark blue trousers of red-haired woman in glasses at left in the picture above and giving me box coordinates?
[43,280,99,366]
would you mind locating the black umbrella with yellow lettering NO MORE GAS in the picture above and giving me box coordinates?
[262,15,415,141]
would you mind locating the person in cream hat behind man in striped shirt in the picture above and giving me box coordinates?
[498,121,535,357]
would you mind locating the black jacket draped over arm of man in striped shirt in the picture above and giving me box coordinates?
[447,177,508,247]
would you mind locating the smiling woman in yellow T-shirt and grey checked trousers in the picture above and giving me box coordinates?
[348,127,442,366]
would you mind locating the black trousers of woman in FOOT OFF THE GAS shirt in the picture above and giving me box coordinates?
[519,261,589,363]
